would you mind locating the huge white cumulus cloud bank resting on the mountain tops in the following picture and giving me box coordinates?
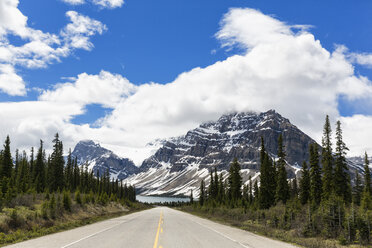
[0,9,372,161]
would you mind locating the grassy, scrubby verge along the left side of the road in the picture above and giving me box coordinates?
[0,195,150,247]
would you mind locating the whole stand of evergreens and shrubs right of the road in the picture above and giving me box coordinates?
[197,116,372,243]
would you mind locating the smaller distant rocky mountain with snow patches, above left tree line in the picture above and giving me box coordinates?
[71,140,139,180]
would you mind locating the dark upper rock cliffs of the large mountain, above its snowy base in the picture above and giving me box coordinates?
[141,110,315,172]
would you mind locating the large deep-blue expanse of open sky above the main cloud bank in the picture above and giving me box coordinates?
[11,0,372,94]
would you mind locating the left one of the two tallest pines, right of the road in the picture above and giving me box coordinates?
[322,115,334,199]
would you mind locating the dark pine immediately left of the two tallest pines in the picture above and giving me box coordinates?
[309,143,322,206]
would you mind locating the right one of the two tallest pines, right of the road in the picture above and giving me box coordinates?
[334,121,352,203]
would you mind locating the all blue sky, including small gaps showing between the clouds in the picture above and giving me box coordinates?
[0,0,372,159]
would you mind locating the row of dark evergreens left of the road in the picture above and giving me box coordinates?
[0,133,136,209]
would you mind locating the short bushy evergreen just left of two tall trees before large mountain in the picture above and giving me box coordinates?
[228,158,242,201]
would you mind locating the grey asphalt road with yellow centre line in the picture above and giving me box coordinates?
[8,207,295,248]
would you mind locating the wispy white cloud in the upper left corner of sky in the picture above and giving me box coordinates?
[0,0,107,95]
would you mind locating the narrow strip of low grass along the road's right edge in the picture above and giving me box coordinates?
[176,205,370,248]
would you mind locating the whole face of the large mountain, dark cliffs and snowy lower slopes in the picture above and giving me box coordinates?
[128,110,315,195]
